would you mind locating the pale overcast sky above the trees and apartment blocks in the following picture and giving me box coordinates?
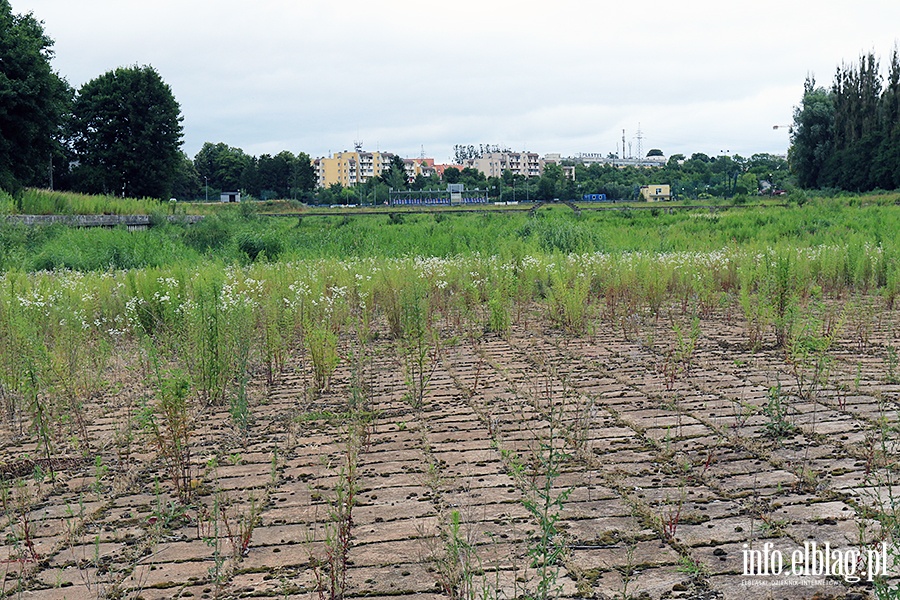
[11,0,900,162]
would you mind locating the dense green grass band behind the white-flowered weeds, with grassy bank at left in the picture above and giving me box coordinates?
[0,192,900,271]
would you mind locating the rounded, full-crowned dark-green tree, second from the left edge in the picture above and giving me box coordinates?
[72,66,182,198]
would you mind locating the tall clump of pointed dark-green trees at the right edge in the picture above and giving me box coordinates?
[788,48,900,192]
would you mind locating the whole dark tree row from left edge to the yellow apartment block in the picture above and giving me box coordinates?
[0,0,324,204]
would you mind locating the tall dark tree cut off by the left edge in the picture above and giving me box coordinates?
[0,0,72,192]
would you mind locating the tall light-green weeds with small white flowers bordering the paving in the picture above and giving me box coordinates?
[0,240,898,402]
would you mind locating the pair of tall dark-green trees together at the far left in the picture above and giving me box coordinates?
[0,0,182,197]
